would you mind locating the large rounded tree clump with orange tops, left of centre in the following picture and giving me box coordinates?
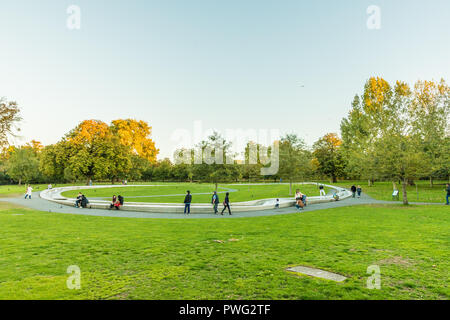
[40,120,158,183]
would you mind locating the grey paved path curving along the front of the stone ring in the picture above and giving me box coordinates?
[0,193,442,219]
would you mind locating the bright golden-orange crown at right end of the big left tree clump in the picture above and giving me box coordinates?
[111,119,159,163]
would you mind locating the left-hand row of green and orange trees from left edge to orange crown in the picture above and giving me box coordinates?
[0,119,159,184]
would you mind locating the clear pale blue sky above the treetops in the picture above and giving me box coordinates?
[0,0,450,158]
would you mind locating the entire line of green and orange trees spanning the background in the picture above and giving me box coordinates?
[0,78,450,203]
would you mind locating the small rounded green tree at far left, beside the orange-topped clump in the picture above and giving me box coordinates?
[7,148,40,185]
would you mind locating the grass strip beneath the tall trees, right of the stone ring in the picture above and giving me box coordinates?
[324,180,447,203]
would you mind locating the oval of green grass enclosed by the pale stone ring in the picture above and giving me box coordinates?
[62,183,328,203]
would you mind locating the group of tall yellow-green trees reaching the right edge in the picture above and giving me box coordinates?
[341,78,450,204]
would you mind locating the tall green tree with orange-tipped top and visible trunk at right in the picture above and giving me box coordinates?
[341,78,430,204]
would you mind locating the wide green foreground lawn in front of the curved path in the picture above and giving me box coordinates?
[0,202,450,299]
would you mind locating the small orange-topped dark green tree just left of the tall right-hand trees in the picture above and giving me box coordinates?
[313,133,345,182]
